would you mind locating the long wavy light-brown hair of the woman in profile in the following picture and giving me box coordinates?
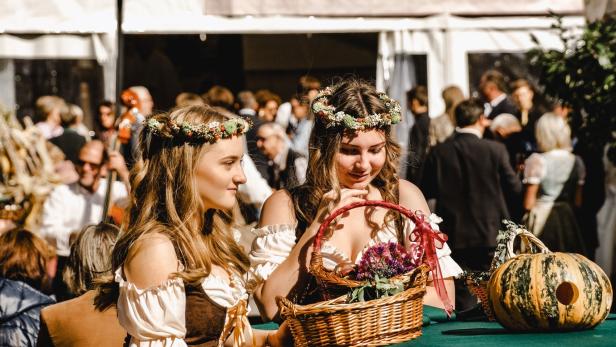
[96,106,249,309]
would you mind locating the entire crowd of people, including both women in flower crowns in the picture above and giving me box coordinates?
[0,71,614,346]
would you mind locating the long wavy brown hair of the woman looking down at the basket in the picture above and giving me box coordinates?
[290,79,402,238]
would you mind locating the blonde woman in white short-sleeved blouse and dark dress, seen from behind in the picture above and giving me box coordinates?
[524,113,586,254]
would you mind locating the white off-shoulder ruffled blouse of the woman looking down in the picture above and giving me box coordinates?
[249,214,463,283]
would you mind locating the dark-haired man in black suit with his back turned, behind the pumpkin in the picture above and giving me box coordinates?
[421,99,522,310]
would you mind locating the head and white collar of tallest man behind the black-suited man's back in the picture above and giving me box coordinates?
[479,70,518,119]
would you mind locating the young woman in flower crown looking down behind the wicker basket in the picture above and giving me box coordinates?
[250,80,462,319]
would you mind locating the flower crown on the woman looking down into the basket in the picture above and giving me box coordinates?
[311,87,402,130]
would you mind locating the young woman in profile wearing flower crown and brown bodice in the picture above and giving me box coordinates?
[96,106,286,346]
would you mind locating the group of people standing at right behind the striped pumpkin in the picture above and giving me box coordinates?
[406,70,600,309]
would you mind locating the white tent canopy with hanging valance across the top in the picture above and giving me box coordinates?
[0,0,588,111]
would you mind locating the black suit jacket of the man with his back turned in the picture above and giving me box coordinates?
[421,132,522,249]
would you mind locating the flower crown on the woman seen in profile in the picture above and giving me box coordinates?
[145,117,252,143]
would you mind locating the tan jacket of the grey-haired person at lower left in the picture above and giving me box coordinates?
[37,290,127,347]
